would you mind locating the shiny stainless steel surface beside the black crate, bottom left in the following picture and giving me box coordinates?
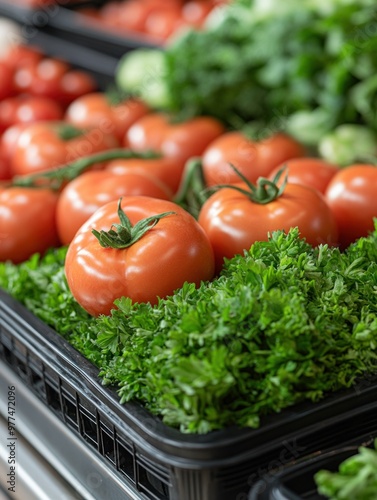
[0,361,140,500]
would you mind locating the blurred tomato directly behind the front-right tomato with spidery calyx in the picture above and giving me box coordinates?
[203,131,305,186]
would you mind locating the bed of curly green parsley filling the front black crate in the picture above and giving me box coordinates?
[0,227,377,433]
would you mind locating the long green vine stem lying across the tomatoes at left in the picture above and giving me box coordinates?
[8,149,161,190]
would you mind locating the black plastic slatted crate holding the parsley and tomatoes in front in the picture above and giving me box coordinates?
[0,290,377,500]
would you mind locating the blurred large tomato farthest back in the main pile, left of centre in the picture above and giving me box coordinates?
[65,92,149,141]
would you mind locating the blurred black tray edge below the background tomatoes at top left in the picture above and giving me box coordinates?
[42,1,160,59]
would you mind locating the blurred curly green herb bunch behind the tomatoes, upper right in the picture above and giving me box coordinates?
[164,0,377,133]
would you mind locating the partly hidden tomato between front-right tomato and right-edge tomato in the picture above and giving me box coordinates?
[269,158,339,194]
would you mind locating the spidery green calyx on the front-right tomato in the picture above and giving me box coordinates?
[210,163,288,205]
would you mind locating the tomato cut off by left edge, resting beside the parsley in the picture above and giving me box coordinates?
[0,187,59,264]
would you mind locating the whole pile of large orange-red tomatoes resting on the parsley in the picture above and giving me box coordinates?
[0,44,377,315]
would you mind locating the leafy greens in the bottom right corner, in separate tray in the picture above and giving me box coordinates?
[314,439,377,500]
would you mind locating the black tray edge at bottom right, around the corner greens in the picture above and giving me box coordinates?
[249,433,377,500]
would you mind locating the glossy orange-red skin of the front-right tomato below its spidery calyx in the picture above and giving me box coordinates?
[198,183,338,272]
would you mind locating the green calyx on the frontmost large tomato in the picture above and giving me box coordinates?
[92,198,176,249]
